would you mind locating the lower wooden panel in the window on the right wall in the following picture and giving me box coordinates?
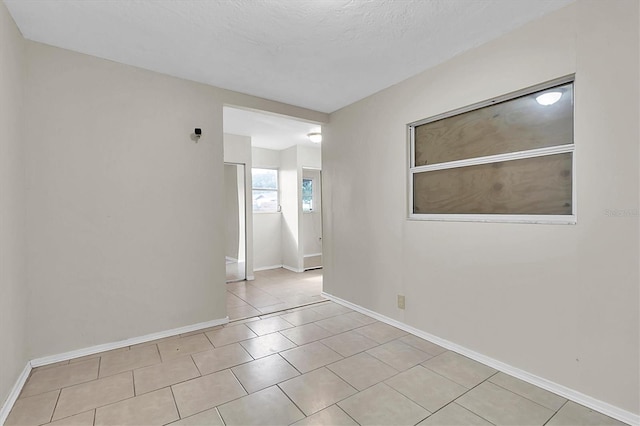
[413,153,572,215]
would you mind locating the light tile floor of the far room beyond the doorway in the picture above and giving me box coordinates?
[227,268,325,320]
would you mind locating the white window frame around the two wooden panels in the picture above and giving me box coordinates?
[407,74,577,225]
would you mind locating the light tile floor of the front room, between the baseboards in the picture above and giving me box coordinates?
[6,286,622,426]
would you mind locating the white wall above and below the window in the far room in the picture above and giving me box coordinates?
[251,147,282,269]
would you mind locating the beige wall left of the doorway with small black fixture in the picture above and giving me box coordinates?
[22,42,326,358]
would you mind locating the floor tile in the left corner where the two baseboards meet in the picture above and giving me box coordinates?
[20,358,100,398]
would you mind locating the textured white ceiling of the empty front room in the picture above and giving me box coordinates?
[4,0,573,112]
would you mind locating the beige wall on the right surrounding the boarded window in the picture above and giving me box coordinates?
[322,0,640,413]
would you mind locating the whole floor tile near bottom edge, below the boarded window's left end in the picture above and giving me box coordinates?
[385,365,468,413]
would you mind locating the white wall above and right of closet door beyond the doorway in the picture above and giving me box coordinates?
[224,133,254,280]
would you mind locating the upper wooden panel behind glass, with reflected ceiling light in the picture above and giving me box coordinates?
[415,83,573,166]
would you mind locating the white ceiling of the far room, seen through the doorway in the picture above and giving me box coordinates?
[223,107,321,150]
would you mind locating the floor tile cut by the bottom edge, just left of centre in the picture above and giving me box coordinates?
[218,386,304,426]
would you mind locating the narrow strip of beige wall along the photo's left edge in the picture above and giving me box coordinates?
[0,2,28,407]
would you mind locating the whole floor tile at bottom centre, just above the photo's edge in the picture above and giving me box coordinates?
[279,367,357,416]
